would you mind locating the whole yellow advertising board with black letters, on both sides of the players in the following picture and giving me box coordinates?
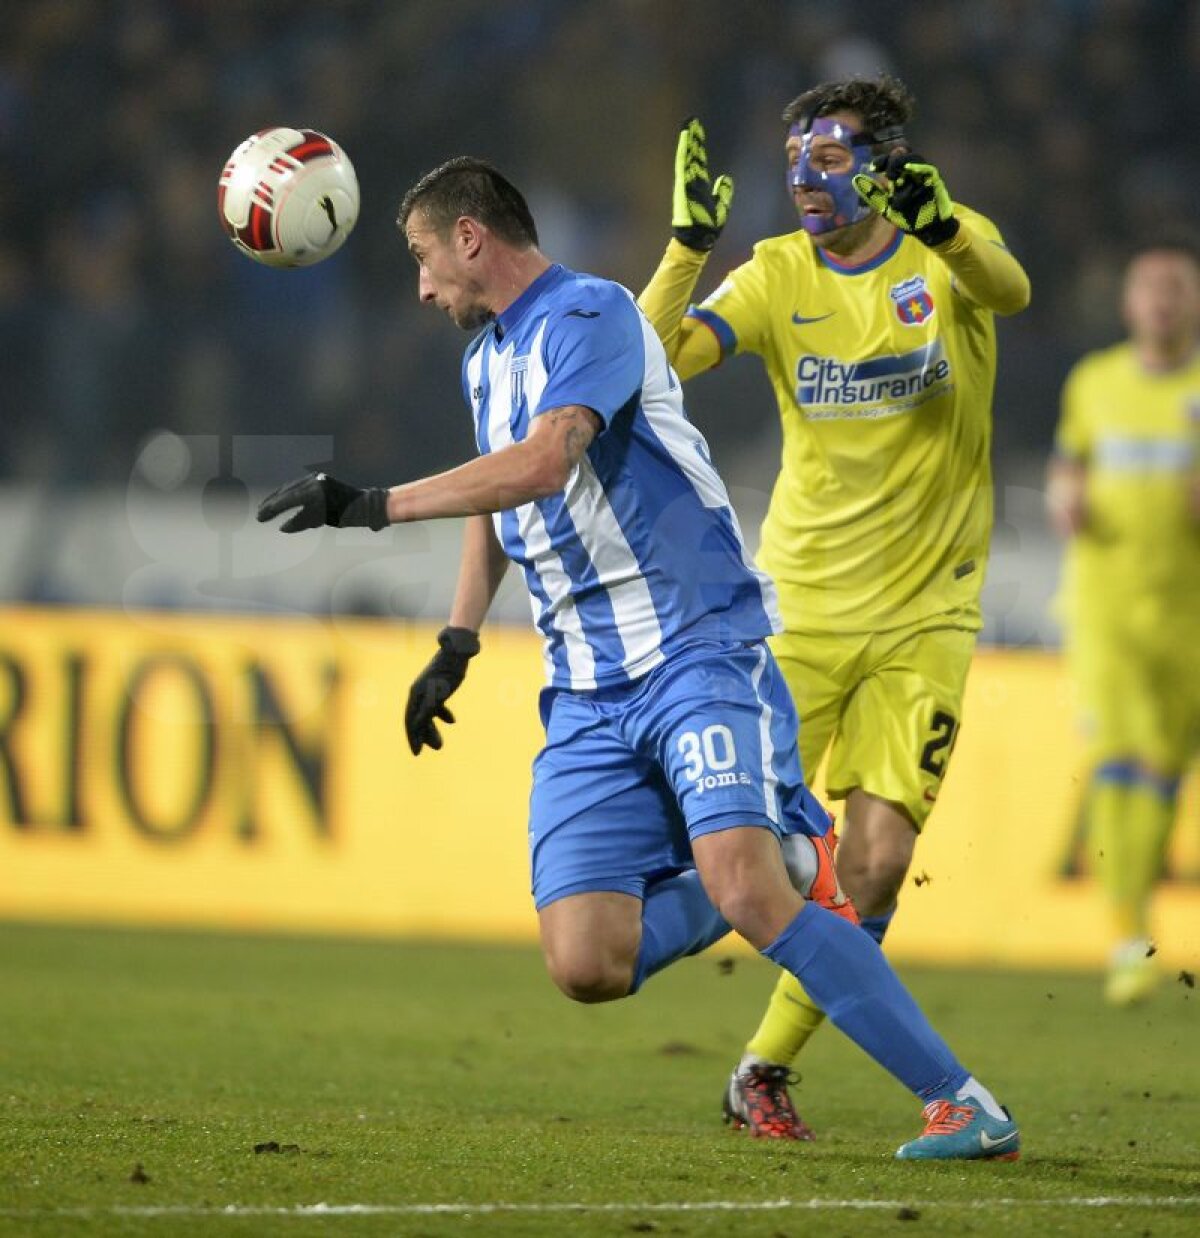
[0,610,1200,966]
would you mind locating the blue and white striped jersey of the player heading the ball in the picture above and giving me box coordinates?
[463,266,780,690]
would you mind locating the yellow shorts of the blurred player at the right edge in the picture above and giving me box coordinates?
[1066,625,1200,774]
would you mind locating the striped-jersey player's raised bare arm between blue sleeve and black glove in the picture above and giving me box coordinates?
[388,405,599,525]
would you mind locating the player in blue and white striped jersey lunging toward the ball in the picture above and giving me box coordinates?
[259,157,1019,1160]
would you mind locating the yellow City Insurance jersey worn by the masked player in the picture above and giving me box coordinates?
[687,206,1003,633]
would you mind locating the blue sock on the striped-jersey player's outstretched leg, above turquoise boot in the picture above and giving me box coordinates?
[763,903,970,1101]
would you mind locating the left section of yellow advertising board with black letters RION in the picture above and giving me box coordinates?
[0,612,541,937]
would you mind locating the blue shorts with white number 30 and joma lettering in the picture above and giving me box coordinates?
[529,643,830,909]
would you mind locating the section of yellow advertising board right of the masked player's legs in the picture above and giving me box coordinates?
[888,650,1200,968]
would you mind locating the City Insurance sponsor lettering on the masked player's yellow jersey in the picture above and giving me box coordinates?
[796,339,950,420]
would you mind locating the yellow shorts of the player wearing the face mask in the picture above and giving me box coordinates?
[770,615,976,829]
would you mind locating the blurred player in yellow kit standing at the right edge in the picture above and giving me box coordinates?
[1046,244,1200,1005]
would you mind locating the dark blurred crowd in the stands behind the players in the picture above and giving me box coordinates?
[0,0,1200,619]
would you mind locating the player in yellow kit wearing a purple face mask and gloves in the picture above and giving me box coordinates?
[639,77,1029,1139]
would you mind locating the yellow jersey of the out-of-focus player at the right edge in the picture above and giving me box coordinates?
[1055,343,1200,639]
